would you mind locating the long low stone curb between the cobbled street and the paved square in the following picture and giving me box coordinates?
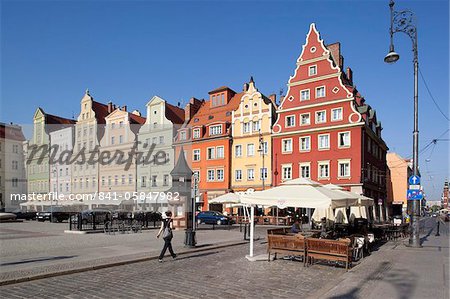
[0,241,248,286]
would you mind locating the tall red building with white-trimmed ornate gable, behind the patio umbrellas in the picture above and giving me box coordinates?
[272,24,388,217]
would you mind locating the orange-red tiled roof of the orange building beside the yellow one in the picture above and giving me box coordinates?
[188,92,245,127]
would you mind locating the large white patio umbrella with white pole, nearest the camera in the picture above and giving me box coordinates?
[241,178,358,259]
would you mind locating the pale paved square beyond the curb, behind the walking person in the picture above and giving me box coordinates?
[0,221,251,281]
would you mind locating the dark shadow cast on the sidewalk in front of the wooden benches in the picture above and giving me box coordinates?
[330,262,418,299]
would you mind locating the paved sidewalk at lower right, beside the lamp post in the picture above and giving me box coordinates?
[310,218,449,299]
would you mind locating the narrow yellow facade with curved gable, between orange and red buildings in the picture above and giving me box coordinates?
[230,78,276,191]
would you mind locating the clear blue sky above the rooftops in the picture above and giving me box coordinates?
[0,0,449,200]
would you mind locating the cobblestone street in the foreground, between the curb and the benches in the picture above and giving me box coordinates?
[0,242,345,298]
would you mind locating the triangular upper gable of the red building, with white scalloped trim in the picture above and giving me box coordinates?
[273,23,361,134]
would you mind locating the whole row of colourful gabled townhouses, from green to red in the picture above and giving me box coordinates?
[0,24,400,217]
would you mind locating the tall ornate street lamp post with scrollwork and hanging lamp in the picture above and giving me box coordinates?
[384,0,421,247]
